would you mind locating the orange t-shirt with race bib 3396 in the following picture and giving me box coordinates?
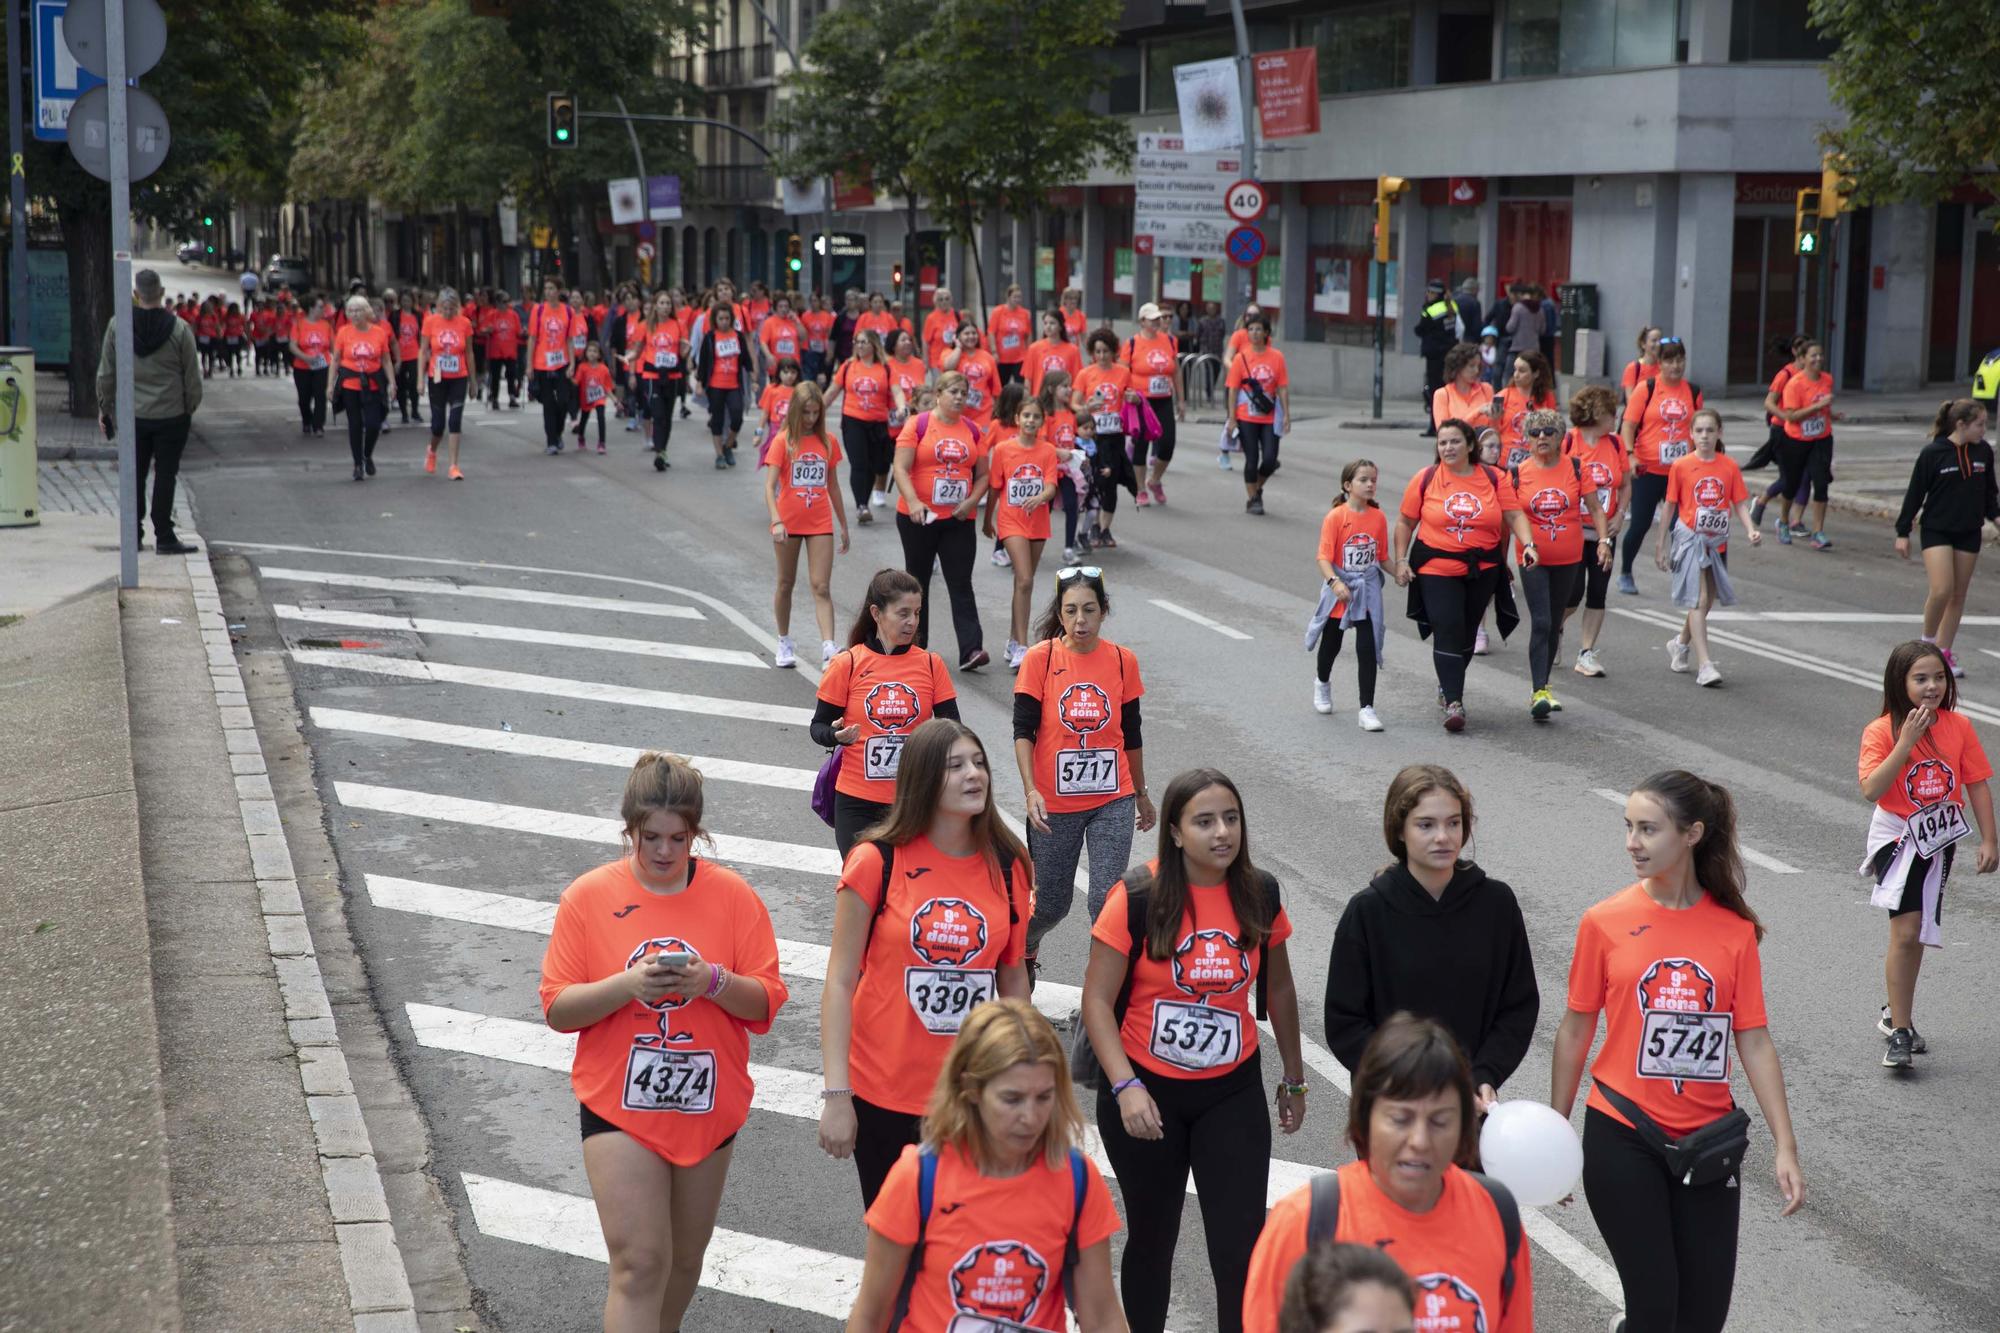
[834,835,1034,1115]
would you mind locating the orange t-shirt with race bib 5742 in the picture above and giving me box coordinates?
[1568,885,1768,1139]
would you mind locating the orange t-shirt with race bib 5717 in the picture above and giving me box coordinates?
[1014,636,1146,815]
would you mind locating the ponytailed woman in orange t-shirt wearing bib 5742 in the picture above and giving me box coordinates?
[1548,771,1806,1333]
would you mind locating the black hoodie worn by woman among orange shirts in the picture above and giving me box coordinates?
[1326,861,1542,1089]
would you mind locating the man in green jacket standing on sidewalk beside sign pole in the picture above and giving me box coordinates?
[98,268,202,554]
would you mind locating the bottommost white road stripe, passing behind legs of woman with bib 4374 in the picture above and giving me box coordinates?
[458,1171,862,1319]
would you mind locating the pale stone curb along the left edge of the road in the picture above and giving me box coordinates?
[182,542,418,1333]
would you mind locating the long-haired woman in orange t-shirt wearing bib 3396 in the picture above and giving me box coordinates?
[820,717,1034,1207]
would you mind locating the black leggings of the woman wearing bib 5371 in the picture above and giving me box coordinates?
[1098,1053,1270,1333]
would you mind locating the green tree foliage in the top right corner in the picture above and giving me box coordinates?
[1810,0,2000,216]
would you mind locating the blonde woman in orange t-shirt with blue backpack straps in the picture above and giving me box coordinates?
[848,999,1126,1333]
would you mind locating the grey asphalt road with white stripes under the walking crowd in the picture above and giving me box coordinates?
[184,360,2000,1333]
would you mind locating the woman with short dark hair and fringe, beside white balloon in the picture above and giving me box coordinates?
[1240,1013,1536,1333]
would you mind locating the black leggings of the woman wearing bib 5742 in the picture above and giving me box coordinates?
[1584,1107,1742,1333]
